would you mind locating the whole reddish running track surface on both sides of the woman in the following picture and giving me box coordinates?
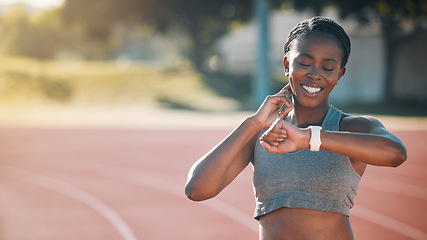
[0,129,427,240]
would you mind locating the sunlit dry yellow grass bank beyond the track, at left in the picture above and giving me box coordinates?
[0,56,237,111]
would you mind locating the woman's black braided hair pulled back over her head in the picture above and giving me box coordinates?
[284,16,351,67]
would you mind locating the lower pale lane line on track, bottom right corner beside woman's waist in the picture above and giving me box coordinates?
[350,206,427,240]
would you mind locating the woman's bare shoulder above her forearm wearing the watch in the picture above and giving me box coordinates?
[340,113,385,133]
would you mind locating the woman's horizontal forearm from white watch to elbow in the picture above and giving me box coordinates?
[320,131,406,167]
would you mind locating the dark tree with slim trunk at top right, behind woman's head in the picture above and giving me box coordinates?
[271,0,427,101]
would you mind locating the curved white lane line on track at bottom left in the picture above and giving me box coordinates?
[1,165,137,240]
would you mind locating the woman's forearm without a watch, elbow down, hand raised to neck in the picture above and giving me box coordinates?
[185,118,262,200]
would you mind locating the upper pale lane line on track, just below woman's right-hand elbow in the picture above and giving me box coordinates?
[360,176,427,200]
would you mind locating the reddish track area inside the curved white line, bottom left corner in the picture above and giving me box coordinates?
[0,174,122,240]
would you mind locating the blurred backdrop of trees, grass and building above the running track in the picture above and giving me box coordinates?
[0,0,427,128]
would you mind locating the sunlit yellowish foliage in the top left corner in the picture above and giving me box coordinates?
[0,4,118,59]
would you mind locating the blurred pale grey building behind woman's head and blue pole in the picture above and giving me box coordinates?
[216,11,427,104]
